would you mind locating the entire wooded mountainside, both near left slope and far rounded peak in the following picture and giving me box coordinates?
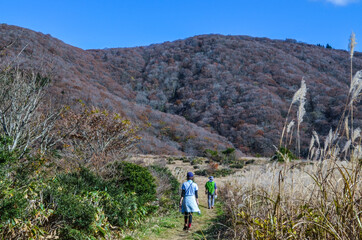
[0,25,362,155]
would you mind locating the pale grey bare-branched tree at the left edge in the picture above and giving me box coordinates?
[0,67,60,156]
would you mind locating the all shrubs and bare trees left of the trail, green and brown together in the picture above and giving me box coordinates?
[0,66,163,240]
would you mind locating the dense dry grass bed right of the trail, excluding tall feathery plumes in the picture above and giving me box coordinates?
[221,160,362,239]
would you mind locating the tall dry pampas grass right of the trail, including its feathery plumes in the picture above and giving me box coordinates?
[219,34,362,239]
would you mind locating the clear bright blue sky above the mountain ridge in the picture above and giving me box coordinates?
[0,0,362,51]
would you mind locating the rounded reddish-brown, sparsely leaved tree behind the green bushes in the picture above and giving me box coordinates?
[60,102,140,167]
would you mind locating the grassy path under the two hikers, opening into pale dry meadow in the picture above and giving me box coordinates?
[126,155,267,240]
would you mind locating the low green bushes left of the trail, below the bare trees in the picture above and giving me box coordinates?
[0,163,158,239]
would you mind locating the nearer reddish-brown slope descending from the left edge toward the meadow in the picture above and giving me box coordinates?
[0,24,241,155]
